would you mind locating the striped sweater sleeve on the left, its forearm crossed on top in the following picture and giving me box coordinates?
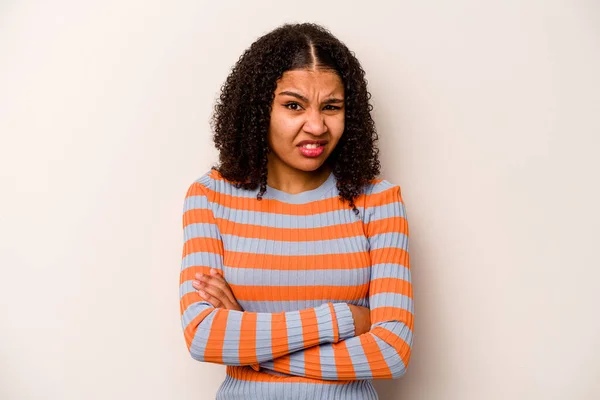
[179,181,354,365]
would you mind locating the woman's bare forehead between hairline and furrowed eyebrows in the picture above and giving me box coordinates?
[277,69,344,93]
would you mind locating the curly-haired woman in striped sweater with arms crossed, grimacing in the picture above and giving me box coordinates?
[180,24,413,400]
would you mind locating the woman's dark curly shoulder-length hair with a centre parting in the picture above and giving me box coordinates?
[211,23,381,215]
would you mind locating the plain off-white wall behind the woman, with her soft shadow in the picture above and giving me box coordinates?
[0,0,600,400]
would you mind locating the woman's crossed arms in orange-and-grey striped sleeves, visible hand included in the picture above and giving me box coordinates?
[180,181,413,380]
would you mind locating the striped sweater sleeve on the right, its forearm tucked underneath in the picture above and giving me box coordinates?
[255,181,414,380]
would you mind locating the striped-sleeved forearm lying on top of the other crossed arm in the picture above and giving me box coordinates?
[182,293,354,365]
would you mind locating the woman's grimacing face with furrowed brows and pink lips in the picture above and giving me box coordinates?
[267,69,345,174]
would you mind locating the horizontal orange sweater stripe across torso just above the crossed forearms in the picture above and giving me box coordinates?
[229,283,369,301]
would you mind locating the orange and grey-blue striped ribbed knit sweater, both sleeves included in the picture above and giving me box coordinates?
[180,169,414,400]
